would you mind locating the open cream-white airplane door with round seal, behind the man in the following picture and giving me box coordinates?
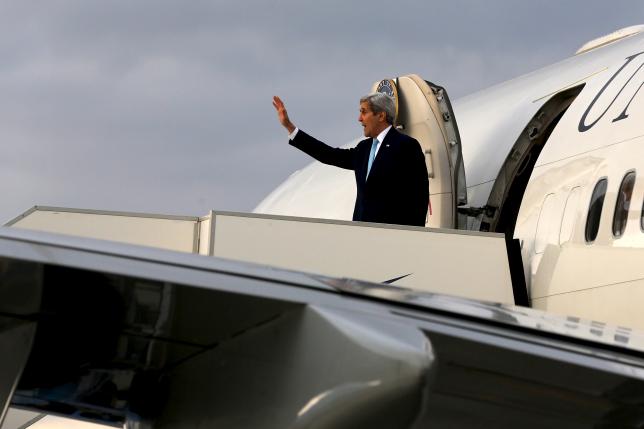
[372,74,467,228]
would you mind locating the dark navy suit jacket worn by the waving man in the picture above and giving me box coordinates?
[289,127,429,226]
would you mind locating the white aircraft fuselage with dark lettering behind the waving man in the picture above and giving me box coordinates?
[256,26,644,328]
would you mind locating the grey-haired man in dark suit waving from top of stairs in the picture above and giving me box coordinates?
[273,93,429,226]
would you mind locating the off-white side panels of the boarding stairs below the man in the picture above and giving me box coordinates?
[6,206,528,305]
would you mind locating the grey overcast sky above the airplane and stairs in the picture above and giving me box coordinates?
[0,0,644,223]
